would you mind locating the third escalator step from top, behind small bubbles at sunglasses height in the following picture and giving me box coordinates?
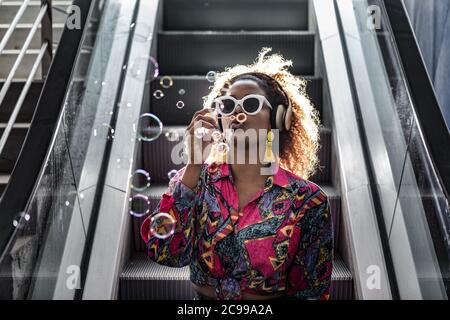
[150,76,322,126]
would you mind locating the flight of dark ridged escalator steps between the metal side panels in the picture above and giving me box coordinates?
[120,1,353,299]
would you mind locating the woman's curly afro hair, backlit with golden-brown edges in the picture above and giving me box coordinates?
[203,47,320,179]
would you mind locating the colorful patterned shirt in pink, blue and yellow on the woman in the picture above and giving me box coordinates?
[141,164,334,300]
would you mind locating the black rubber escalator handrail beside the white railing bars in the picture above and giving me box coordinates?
[0,0,93,253]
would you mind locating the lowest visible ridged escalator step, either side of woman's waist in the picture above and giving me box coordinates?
[119,254,353,300]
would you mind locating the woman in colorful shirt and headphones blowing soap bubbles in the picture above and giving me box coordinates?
[141,48,333,300]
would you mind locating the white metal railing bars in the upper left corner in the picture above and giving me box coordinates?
[0,0,52,155]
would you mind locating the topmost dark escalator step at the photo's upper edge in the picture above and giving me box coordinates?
[163,0,308,30]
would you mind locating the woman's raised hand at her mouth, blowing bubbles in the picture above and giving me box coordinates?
[185,108,219,167]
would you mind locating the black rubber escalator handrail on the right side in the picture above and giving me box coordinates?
[383,0,450,199]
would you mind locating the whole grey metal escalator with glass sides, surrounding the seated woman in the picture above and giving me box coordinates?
[0,0,450,300]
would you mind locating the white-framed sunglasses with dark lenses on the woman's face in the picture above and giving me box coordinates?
[213,94,273,116]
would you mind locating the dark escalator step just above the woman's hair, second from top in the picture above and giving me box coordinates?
[158,31,315,75]
